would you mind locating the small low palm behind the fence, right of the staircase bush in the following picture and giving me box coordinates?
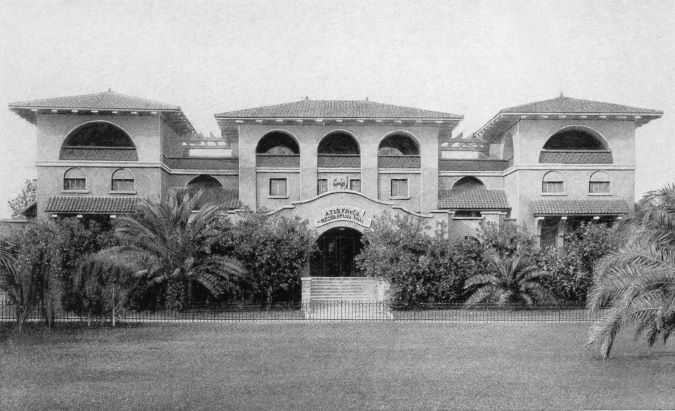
[464,253,553,306]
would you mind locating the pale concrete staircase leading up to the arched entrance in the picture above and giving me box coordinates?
[302,277,392,320]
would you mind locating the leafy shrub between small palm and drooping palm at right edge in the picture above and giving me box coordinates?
[539,223,626,302]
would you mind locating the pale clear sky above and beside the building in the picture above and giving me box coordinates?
[0,0,675,217]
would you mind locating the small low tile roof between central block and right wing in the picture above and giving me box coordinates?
[438,188,511,210]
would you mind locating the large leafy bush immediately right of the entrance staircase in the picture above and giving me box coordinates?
[356,215,484,305]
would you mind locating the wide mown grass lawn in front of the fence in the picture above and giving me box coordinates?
[0,323,675,410]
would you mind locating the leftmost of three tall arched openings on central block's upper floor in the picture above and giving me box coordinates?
[255,131,300,167]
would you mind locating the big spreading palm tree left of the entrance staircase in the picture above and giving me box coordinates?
[115,189,245,309]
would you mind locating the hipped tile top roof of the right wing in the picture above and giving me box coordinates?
[499,95,663,114]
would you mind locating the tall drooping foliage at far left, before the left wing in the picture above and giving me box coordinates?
[0,219,113,327]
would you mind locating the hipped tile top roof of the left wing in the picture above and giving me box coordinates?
[9,89,180,110]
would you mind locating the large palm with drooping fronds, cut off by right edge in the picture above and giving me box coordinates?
[587,185,675,358]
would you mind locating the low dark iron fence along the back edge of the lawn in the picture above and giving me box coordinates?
[0,301,598,323]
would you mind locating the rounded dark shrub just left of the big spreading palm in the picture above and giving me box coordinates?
[73,252,142,327]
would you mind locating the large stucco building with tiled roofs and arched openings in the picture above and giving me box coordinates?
[9,90,663,282]
